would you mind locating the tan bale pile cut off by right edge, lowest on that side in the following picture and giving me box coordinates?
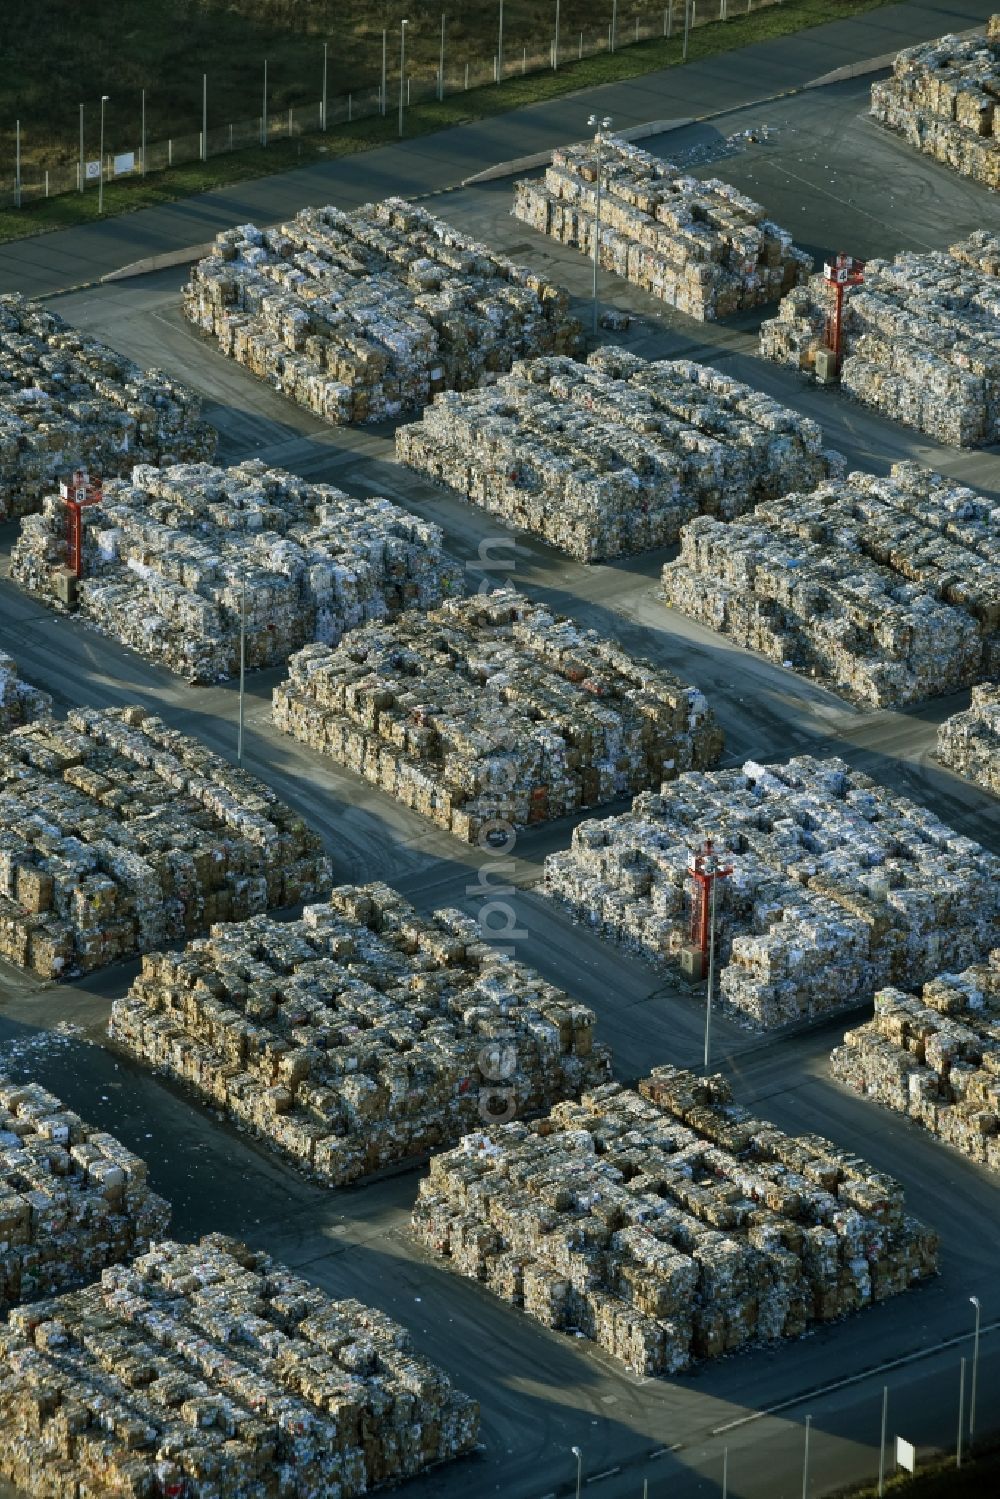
[831,949,1000,1171]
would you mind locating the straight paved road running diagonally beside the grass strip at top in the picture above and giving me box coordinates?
[0,0,996,297]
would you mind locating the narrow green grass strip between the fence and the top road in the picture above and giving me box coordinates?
[0,0,891,241]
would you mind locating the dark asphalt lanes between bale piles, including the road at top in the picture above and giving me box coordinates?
[0,4,1000,1499]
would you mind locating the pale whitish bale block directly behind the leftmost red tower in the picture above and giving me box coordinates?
[10,460,460,682]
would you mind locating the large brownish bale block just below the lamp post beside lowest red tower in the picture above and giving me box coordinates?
[414,1067,937,1375]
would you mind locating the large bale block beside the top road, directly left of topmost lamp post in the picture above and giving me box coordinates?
[184,198,580,423]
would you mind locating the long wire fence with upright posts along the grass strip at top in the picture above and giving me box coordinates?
[0,0,781,208]
